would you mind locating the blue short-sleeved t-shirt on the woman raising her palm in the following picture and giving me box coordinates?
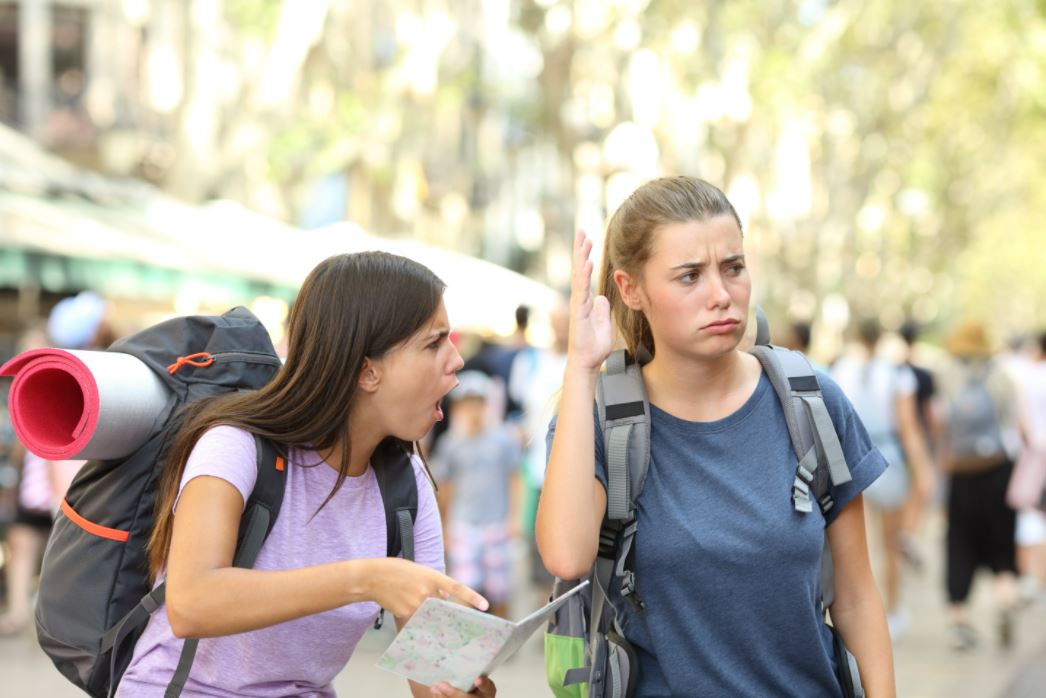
[549,374,886,698]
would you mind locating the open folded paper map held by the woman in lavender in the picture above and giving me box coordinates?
[378,580,588,691]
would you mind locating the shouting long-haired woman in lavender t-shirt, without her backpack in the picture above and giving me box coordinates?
[118,252,496,697]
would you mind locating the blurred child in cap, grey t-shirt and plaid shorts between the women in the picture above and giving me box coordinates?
[432,370,520,617]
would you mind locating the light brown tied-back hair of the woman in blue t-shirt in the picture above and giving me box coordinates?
[599,177,742,356]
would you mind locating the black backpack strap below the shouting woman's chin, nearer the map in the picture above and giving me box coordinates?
[373,442,417,561]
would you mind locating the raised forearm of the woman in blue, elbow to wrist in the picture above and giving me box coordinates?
[536,365,602,578]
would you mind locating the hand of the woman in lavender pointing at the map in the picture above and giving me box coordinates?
[366,558,490,618]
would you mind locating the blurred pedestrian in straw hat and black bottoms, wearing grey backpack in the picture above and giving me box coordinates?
[937,322,1018,650]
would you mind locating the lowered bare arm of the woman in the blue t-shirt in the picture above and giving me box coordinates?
[827,496,896,698]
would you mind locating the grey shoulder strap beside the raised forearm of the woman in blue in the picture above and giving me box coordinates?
[596,350,651,522]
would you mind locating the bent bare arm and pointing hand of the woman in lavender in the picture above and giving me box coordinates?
[166,476,486,637]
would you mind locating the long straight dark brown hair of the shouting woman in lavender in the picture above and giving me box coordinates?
[149,252,446,579]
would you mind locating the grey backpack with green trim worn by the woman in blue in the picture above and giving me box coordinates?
[545,310,864,698]
